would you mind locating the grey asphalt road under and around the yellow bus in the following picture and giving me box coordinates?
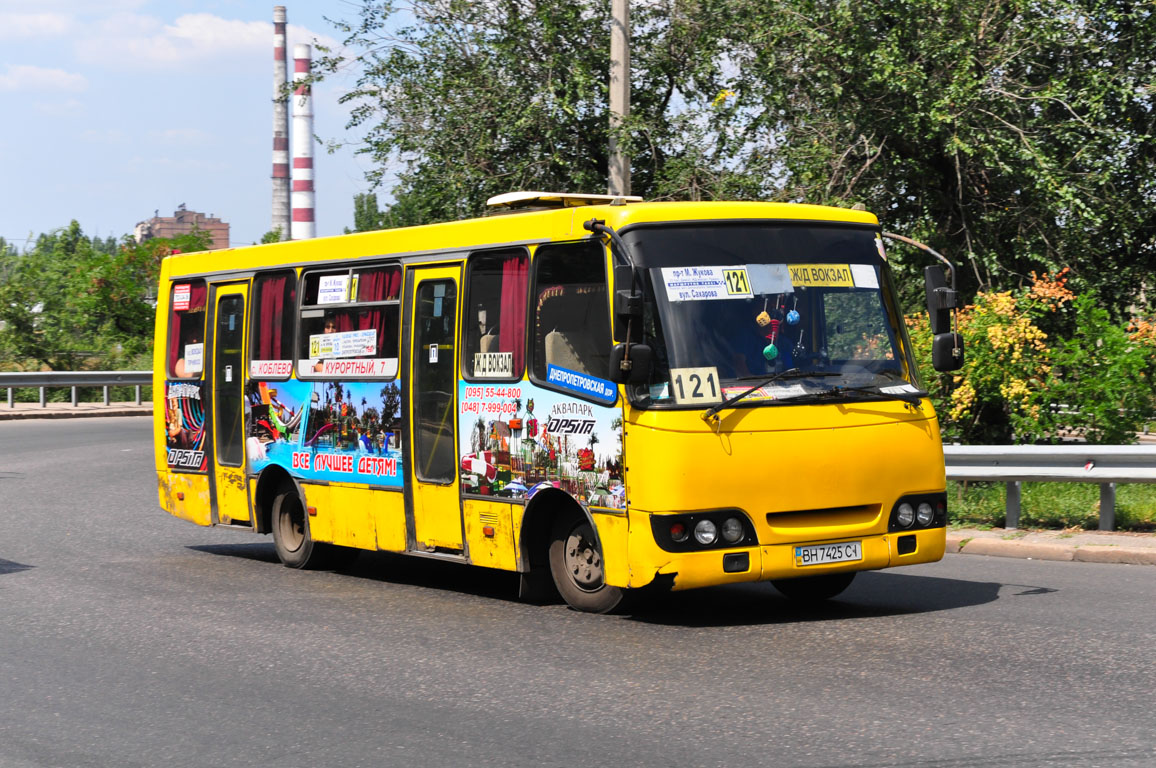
[0,418,1156,768]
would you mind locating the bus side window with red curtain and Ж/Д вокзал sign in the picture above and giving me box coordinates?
[461,249,529,379]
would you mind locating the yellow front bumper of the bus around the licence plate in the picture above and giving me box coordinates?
[629,525,947,590]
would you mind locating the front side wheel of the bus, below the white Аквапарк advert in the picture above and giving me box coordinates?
[550,515,624,613]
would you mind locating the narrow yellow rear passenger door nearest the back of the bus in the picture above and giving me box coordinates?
[209,285,250,525]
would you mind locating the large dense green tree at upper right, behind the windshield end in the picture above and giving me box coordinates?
[724,0,1156,309]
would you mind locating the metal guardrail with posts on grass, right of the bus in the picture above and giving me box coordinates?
[943,445,1156,531]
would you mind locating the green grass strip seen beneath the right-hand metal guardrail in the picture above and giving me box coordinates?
[947,480,1156,531]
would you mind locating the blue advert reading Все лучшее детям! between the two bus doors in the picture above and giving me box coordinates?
[245,381,402,487]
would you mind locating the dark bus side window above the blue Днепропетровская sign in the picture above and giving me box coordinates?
[533,241,610,381]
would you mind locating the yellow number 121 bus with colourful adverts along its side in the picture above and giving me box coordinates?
[154,192,962,612]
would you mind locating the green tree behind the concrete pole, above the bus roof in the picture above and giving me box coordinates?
[324,0,728,226]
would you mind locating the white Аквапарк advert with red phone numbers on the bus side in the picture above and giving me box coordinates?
[458,382,625,509]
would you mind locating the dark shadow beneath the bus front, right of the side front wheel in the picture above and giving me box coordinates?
[630,571,1002,627]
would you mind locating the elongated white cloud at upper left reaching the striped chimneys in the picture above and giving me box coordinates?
[76,14,338,67]
